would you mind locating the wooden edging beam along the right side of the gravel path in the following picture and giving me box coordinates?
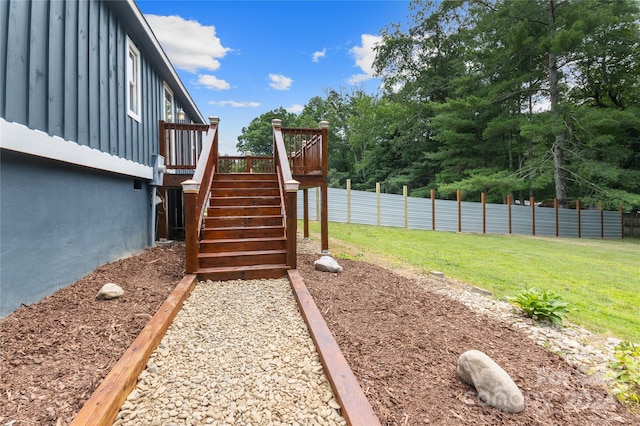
[287,269,380,426]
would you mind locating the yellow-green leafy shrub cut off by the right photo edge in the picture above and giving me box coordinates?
[611,342,640,406]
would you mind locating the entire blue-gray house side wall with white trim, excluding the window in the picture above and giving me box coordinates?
[0,0,203,316]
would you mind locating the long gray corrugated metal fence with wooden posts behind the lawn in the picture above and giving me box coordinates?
[298,188,623,238]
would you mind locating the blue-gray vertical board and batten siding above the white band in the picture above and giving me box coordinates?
[0,0,178,166]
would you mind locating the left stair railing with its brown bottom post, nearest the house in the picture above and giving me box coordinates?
[181,117,219,274]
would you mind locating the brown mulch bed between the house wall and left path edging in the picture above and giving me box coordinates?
[0,244,184,426]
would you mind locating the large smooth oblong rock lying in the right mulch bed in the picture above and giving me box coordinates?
[458,350,524,413]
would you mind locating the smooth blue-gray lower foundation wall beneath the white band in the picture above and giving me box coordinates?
[0,151,150,316]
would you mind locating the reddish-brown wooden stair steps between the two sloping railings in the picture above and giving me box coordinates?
[197,173,289,280]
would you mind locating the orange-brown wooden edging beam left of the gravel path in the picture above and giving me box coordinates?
[71,275,197,426]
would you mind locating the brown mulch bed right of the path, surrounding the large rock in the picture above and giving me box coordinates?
[298,255,640,425]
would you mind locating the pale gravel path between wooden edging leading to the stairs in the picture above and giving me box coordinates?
[115,279,346,425]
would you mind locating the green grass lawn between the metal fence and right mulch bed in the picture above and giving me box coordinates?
[310,222,640,342]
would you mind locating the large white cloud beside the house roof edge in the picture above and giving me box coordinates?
[145,15,231,72]
